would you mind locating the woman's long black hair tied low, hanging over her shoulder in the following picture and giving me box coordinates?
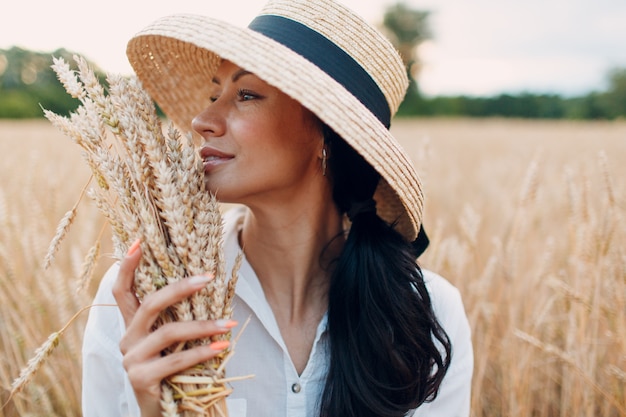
[320,126,451,417]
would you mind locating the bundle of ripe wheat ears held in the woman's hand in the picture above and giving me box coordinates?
[12,56,246,417]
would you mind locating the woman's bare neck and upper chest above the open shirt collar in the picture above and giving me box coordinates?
[241,196,343,323]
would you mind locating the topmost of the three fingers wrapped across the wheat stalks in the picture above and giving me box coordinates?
[122,275,213,338]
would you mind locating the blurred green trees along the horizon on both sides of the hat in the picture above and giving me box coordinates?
[0,2,626,120]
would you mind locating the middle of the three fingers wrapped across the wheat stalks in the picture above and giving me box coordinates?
[123,320,237,363]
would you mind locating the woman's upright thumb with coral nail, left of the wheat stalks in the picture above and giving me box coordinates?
[112,239,141,326]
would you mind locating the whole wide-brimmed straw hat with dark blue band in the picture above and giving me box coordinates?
[127,0,423,241]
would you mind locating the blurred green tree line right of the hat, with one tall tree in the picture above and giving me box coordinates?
[381,1,626,119]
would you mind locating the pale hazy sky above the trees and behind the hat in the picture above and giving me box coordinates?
[0,0,626,96]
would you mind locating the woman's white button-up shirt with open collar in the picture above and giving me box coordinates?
[82,209,473,417]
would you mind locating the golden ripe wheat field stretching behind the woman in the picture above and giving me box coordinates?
[0,119,626,417]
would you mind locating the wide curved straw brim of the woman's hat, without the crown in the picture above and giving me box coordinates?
[127,15,423,241]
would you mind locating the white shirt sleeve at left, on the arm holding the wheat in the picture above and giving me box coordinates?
[82,264,139,417]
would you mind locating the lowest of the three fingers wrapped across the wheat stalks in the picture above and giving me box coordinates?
[124,341,230,390]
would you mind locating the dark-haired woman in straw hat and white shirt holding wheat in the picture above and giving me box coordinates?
[83,0,473,417]
